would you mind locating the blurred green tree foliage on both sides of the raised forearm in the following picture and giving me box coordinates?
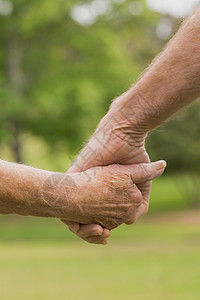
[0,0,200,171]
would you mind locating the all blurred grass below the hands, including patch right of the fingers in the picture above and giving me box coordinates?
[0,177,200,300]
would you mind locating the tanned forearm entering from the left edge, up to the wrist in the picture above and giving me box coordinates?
[0,160,58,217]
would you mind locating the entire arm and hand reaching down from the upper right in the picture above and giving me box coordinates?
[65,7,200,243]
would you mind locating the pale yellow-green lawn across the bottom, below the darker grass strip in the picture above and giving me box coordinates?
[0,224,200,300]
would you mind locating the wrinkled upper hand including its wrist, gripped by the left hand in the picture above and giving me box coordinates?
[66,93,162,244]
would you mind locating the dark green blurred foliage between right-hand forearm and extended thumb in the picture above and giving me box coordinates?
[147,101,200,172]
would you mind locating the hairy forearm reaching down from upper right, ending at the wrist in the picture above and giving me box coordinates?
[111,9,200,133]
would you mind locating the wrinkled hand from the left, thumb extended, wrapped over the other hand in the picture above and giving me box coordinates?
[61,163,164,230]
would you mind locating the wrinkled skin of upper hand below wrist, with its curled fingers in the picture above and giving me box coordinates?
[65,110,165,243]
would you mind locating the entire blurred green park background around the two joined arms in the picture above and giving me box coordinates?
[0,0,200,300]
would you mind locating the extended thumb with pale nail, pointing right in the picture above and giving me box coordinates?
[131,160,167,184]
